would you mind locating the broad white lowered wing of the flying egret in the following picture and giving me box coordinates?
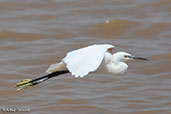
[63,44,114,77]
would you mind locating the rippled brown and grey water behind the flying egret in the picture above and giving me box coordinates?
[0,0,171,114]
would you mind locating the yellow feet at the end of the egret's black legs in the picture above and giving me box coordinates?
[15,79,33,91]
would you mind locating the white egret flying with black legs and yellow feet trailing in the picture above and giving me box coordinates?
[16,44,147,91]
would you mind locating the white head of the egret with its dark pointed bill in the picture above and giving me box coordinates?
[113,52,148,62]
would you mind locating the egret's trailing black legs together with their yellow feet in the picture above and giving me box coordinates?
[15,70,69,91]
